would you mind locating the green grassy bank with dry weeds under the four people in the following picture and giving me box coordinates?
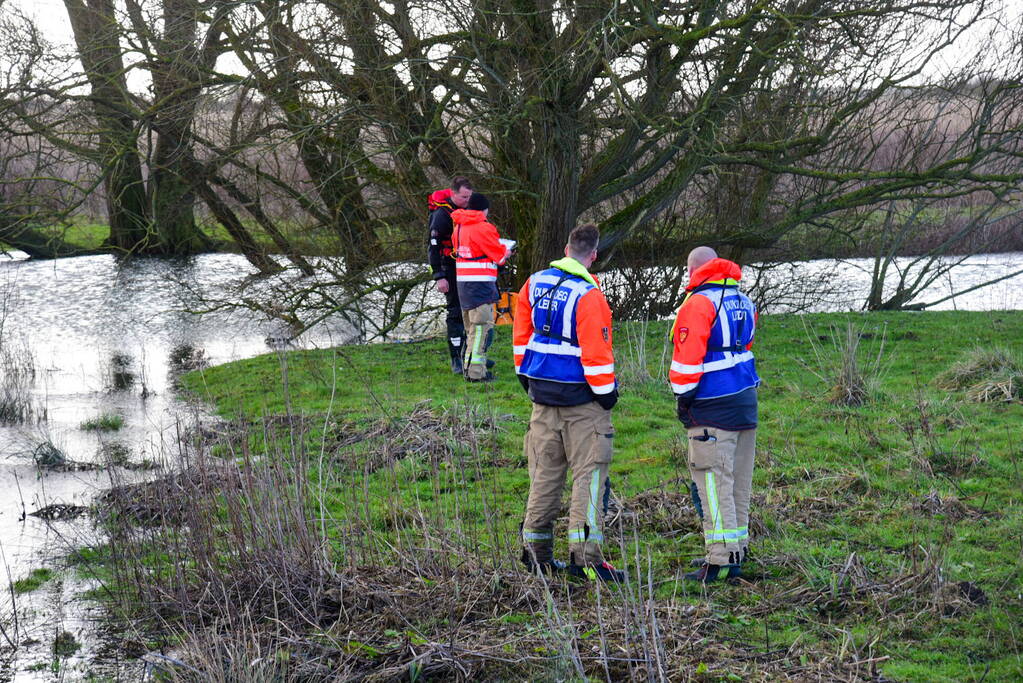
[101,312,1023,681]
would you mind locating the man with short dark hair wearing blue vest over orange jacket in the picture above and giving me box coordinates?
[514,225,624,582]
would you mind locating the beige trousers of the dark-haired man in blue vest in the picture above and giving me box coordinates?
[522,401,615,565]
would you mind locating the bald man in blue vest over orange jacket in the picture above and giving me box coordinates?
[668,246,760,583]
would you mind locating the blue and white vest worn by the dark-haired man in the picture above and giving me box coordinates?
[517,268,594,383]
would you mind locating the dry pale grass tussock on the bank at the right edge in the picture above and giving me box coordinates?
[935,348,1023,403]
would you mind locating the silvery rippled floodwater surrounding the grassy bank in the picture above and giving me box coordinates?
[0,249,1023,681]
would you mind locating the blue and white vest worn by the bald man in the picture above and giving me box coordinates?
[671,287,760,399]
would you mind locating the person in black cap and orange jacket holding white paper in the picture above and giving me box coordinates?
[451,192,512,381]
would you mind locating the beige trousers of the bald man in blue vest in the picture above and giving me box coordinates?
[686,426,757,565]
